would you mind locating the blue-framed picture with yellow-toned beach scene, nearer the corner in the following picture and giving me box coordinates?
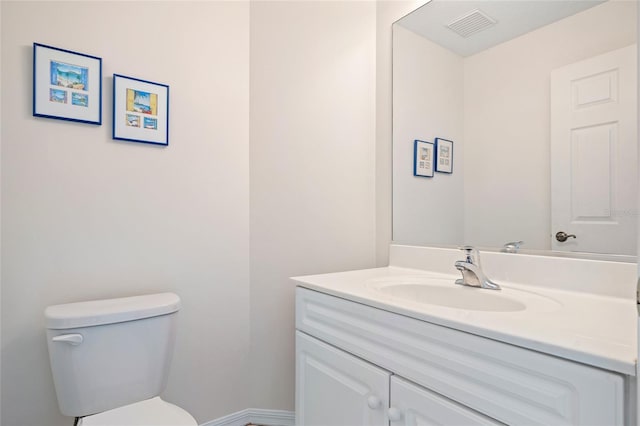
[113,74,169,145]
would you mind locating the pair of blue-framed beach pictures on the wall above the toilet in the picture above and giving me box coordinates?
[33,43,169,145]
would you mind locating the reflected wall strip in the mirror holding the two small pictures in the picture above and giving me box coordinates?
[393,25,465,245]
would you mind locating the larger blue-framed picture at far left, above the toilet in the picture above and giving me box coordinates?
[33,43,102,125]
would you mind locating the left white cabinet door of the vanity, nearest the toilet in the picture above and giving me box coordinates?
[296,331,390,426]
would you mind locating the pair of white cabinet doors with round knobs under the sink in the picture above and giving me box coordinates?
[296,331,500,426]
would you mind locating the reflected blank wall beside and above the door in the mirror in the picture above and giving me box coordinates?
[464,1,636,250]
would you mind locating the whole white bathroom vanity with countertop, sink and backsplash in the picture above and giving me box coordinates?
[294,246,637,426]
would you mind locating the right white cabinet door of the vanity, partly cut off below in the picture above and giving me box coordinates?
[389,376,503,426]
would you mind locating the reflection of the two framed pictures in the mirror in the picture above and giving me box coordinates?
[413,138,453,177]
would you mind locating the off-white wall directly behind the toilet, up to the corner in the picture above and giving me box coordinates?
[1,1,249,426]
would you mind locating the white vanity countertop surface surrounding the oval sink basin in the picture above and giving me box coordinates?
[292,266,637,376]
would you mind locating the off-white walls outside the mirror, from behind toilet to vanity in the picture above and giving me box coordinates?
[0,1,420,420]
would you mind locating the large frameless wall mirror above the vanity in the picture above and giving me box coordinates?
[393,0,638,260]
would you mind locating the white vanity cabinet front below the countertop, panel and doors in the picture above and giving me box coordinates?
[296,287,630,426]
